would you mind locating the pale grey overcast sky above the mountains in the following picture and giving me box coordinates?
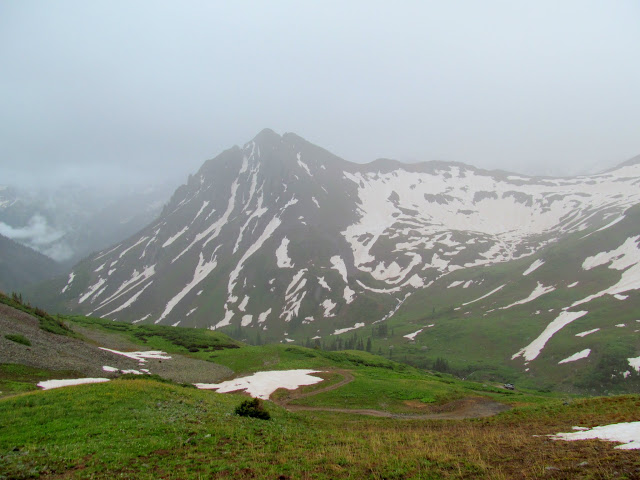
[0,0,640,189]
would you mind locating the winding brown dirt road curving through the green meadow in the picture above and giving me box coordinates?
[276,370,511,420]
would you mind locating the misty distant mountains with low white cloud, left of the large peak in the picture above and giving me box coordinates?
[0,183,174,268]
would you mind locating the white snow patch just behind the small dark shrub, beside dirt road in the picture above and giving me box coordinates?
[195,370,322,400]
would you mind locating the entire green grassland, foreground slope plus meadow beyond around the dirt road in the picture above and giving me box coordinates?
[0,317,640,480]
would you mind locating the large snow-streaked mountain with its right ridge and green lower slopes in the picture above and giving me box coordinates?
[40,130,640,388]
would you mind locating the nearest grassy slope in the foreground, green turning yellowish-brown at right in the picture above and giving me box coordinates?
[0,379,640,479]
